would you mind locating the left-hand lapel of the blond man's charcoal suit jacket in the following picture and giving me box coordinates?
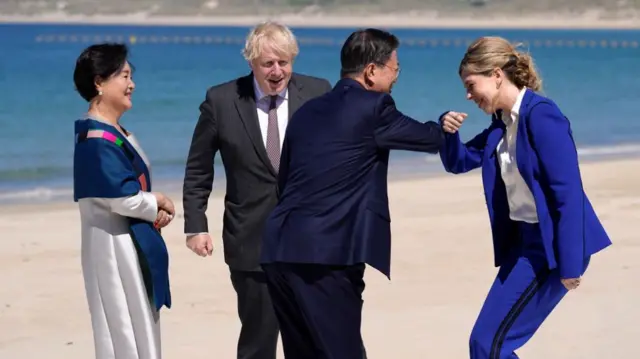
[235,75,276,176]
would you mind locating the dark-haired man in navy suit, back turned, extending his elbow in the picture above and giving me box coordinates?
[261,29,444,359]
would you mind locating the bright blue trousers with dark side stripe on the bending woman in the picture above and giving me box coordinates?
[469,222,589,359]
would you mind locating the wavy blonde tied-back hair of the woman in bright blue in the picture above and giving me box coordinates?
[458,36,542,91]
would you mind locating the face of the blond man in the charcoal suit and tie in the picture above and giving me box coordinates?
[250,46,293,95]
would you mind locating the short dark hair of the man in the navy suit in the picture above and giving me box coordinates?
[340,28,400,77]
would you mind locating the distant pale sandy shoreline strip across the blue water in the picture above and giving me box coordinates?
[0,13,640,30]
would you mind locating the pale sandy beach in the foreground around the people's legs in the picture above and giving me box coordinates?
[0,159,640,359]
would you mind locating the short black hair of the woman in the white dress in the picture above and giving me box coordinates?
[73,43,129,101]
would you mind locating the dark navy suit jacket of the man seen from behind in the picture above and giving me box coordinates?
[262,79,444,277]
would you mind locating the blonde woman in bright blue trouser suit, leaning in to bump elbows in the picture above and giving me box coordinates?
[440,37,611,359]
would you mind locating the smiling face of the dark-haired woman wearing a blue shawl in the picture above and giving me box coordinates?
[97,62,136,112]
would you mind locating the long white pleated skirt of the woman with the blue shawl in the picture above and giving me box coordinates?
[82,227,162,359]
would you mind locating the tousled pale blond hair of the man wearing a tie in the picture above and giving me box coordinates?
[242,21,299,61]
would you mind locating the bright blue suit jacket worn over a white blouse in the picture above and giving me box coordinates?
[440,90,611,278]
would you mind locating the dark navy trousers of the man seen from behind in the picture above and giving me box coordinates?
[263,263,366,359]
